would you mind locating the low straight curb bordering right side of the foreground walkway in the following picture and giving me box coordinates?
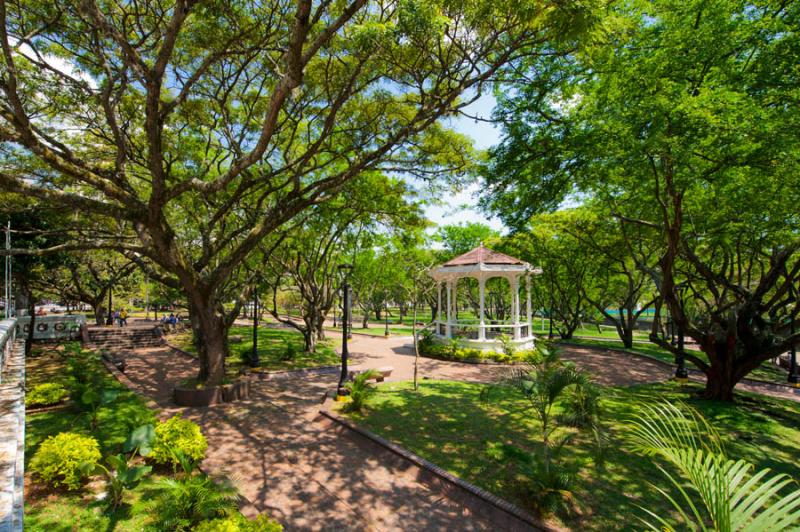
[320,406,552,531]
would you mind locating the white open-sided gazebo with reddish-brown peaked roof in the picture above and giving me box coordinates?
[428,244,542,351]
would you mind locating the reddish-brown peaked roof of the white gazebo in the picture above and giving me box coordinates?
[428,244,541,280]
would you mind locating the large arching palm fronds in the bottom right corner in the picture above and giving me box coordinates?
[631,403,800,532]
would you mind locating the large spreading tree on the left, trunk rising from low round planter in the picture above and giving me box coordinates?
[0,0,592,383]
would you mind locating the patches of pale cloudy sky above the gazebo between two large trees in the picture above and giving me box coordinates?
[425,94,504,231]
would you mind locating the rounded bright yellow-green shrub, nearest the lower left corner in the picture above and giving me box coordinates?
[30,432,101,490]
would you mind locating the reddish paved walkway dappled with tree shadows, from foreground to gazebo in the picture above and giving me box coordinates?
[120,338,506,530]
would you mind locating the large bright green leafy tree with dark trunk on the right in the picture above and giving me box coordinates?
[486,0,800,400]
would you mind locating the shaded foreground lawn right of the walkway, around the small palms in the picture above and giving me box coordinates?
[344,381,800,530]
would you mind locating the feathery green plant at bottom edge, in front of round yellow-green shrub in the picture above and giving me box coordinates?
[149,474,239,531]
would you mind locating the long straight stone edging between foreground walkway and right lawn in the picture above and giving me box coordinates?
[320,406,551,530]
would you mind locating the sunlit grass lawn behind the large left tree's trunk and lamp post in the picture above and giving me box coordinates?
[167,326,339,371]
